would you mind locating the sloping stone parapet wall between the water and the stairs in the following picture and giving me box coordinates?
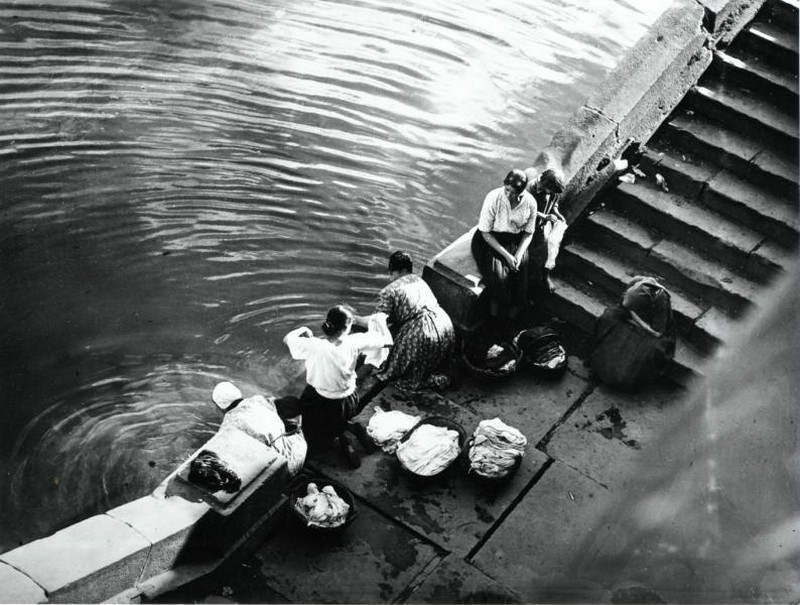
[423,0,765,331]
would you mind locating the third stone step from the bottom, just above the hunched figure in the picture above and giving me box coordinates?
[584,209,760,316]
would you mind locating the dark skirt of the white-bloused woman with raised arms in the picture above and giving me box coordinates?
[275,385,362,449]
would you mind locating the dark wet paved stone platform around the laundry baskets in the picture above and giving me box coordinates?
[158,357,685,603]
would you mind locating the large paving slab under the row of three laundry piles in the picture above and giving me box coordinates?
[309,373,587,556]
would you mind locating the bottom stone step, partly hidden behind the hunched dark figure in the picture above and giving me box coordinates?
[542,275,707,385]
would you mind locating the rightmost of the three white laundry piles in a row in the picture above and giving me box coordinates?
[467,418,528,479]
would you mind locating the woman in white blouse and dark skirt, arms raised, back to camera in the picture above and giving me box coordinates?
[276,306,384,467]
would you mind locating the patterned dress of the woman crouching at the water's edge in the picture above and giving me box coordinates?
[377,274,455,390]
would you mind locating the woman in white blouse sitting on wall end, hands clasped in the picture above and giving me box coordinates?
[472,169,536,332]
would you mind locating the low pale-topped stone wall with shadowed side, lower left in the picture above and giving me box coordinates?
[0,448,287,603]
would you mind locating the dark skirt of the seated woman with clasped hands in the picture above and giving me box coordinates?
[472,229,530,312]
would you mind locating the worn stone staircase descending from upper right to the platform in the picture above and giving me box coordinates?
[545,0,800,382]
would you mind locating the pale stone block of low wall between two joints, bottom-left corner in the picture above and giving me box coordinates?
[0,515,150,603]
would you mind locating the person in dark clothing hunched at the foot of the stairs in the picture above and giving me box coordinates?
[589,276,676,390]
